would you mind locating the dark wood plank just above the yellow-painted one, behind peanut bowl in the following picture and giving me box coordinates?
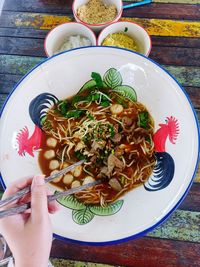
[3,0,200,20]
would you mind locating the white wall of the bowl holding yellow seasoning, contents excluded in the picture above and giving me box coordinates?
[97,21,152,56]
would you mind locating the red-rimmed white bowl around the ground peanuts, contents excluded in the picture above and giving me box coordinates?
[72,0,123,32]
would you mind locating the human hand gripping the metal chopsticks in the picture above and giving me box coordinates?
[0,175,58,267]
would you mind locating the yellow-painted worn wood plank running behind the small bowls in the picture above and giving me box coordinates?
[0,11,200,37]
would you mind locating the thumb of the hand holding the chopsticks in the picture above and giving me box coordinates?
[31,175,48,222]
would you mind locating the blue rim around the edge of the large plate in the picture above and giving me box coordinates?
[0,46,200,246]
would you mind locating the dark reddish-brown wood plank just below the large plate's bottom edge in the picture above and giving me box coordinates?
[51,237,200,267]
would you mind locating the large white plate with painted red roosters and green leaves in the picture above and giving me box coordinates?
[0,47,199,245]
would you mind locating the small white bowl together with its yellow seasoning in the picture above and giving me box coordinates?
[97,21,152,56]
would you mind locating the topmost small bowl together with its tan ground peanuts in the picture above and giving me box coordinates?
[72,0,123,32]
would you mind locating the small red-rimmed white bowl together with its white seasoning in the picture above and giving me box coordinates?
[44,22,97,57]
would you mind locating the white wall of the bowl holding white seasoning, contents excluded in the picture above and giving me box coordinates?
[44,22,97,57]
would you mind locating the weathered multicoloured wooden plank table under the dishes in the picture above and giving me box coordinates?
[0,0,200,267]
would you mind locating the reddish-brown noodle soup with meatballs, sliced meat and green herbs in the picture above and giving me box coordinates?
[39,88,155,206]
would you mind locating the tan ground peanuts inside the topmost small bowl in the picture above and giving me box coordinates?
[77,0,117,24]
